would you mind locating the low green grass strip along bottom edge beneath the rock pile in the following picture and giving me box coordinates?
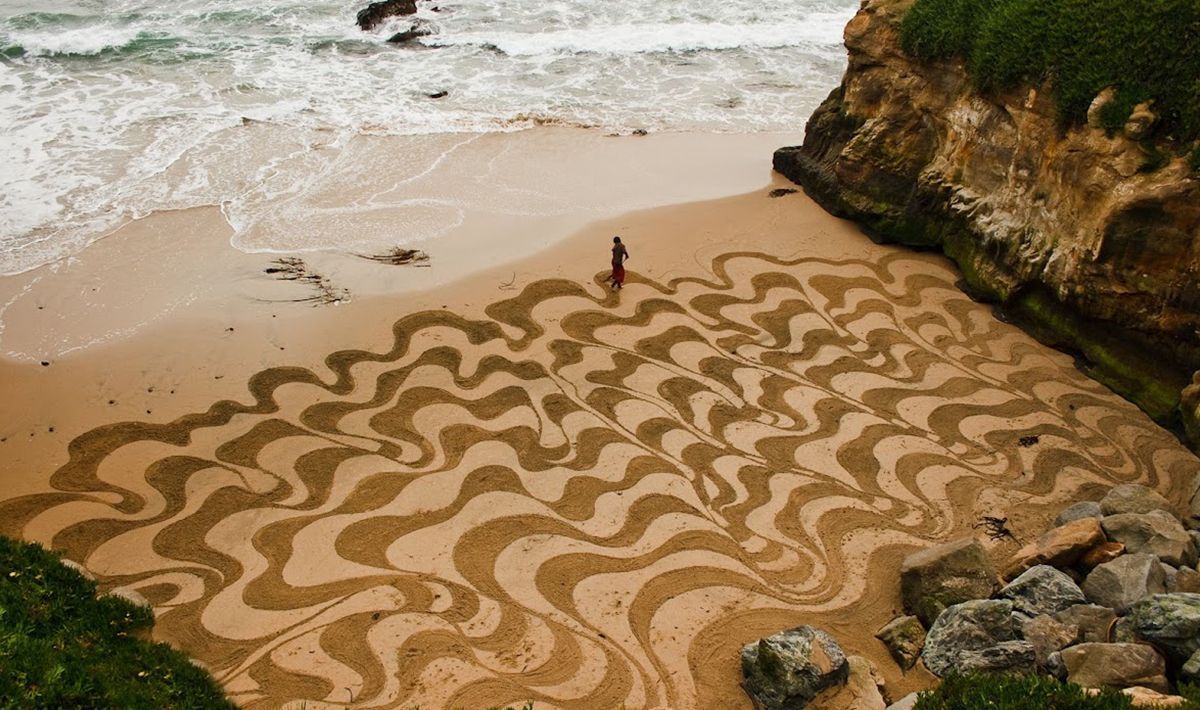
[913,674,1200,710]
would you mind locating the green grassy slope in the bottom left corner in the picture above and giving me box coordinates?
[0,537,234,709]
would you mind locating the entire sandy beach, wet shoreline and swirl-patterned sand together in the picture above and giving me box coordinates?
[0,128,1200,710]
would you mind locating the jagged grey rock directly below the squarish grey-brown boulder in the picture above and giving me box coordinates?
[922,600,1036,676]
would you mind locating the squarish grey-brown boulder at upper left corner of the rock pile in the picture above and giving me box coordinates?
[900,537,1000,626]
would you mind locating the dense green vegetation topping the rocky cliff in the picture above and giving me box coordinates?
[900,0,1200,143]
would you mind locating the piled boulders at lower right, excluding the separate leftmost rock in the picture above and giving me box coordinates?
[878,485,1200,697]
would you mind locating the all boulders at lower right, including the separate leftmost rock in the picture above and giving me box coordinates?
[742,485,1200,710]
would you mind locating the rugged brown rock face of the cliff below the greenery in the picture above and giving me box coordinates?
[775,0,1200,444]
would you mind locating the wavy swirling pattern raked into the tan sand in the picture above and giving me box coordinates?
[0,252,1195,709]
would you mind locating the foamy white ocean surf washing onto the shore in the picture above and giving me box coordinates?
[0,0,858,273]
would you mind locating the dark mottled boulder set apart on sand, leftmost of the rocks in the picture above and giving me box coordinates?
[742,626,850,710]
